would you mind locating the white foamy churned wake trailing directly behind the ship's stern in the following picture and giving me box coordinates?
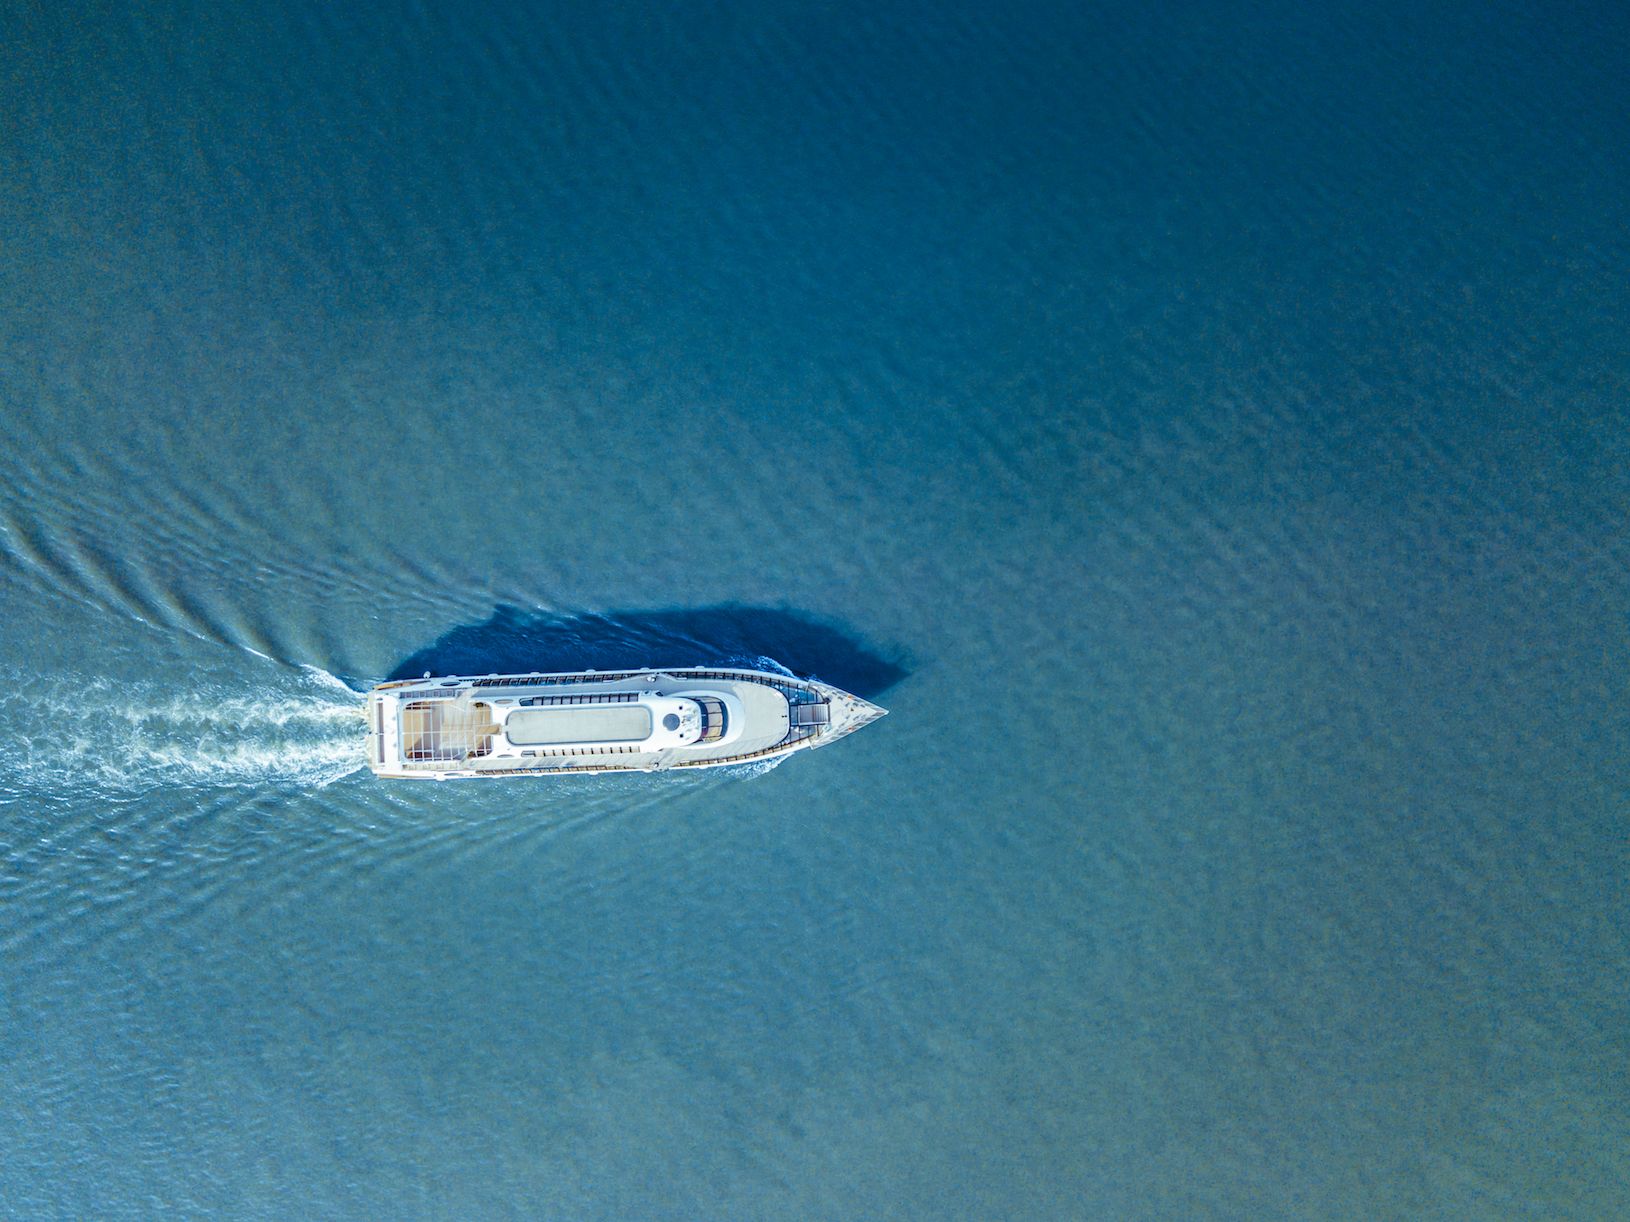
[0,666,365,793]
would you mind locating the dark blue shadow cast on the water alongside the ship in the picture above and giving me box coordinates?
[391,604,910,699]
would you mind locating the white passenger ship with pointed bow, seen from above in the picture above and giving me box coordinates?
[368,668,885,780]
